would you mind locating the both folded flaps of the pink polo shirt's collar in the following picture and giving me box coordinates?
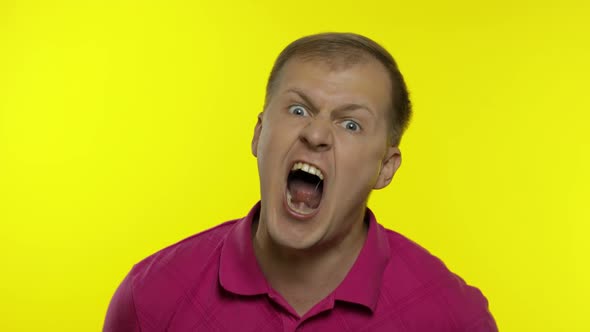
[219,202,390,311]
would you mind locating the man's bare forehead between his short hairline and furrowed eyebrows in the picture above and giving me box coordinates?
[275,57,391,112]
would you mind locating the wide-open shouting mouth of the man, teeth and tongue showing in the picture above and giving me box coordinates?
[286,162,324,217]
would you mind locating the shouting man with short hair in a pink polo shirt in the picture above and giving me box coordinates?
[104,33,497,332]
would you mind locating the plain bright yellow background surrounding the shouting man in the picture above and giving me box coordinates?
[0,0,590,332]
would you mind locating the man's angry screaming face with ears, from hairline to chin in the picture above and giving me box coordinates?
[252,58,401,249]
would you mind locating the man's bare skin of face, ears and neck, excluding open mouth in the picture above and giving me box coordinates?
[252,56,408,315]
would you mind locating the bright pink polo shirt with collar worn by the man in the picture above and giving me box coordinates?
[104,203,498,332]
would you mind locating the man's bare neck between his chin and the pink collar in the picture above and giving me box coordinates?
[253,214,367,315]
